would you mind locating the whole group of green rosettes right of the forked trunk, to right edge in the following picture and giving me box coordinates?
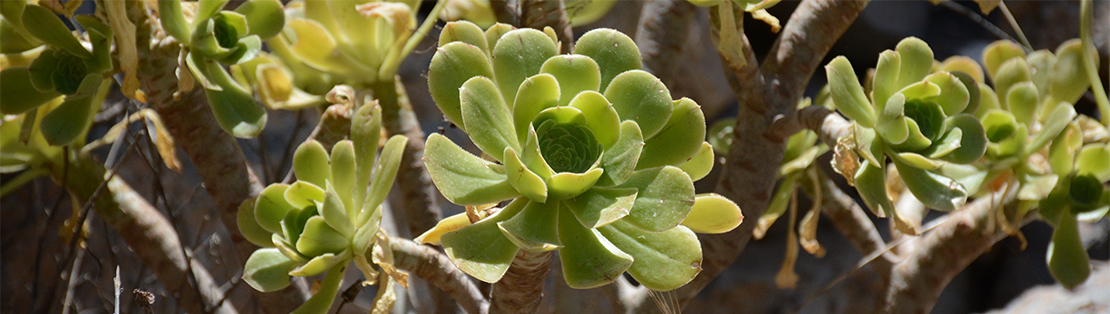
[826,38,1110,286]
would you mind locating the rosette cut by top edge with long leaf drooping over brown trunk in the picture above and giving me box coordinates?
[158,0,285,138]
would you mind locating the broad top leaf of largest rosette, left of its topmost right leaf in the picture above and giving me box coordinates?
[492,29,558,102]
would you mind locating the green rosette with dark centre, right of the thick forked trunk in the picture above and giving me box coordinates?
[826,38,987,233]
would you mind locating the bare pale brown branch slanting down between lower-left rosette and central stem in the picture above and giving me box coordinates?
[390,237,490,314]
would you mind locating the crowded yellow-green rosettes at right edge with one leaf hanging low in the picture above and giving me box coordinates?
[976,40,1110,286]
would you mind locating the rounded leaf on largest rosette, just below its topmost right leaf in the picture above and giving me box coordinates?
[603,70,674,139]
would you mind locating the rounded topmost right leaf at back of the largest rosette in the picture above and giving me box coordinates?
[574,29,643,91]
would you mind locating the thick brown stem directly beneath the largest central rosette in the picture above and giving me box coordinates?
[490,250,552,314]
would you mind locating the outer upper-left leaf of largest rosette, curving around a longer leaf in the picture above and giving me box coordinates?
[427,42,492,131]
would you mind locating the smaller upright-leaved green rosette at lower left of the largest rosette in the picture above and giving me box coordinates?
[239,104,408,310]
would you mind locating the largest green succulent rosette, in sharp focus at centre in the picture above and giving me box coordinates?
[418,22,743,291]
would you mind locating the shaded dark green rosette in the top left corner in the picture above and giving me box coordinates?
[0,1,112,145]
